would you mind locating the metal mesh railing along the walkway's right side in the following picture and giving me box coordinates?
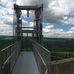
[33,42,50,74]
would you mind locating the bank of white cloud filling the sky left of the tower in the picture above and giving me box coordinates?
[0,0,13,35]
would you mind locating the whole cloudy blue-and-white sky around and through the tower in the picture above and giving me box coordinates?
[0,0,74,38]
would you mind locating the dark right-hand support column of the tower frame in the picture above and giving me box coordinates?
[35,5,43,44]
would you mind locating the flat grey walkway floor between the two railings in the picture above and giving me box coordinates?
[12,52,39,74]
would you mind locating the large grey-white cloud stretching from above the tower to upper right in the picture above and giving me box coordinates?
[16,0,74,24]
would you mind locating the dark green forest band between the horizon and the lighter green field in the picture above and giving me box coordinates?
[44,39,74,51]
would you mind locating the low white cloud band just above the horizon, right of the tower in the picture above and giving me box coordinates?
[43,27,74,38]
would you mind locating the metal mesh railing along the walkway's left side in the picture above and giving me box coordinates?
[0,42,20,74]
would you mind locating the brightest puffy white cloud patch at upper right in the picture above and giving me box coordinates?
[49,0,71,16]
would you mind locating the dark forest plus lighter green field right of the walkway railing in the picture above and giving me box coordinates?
[44,38,74,60]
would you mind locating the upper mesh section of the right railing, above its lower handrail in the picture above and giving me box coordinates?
[34,42,50,63]
